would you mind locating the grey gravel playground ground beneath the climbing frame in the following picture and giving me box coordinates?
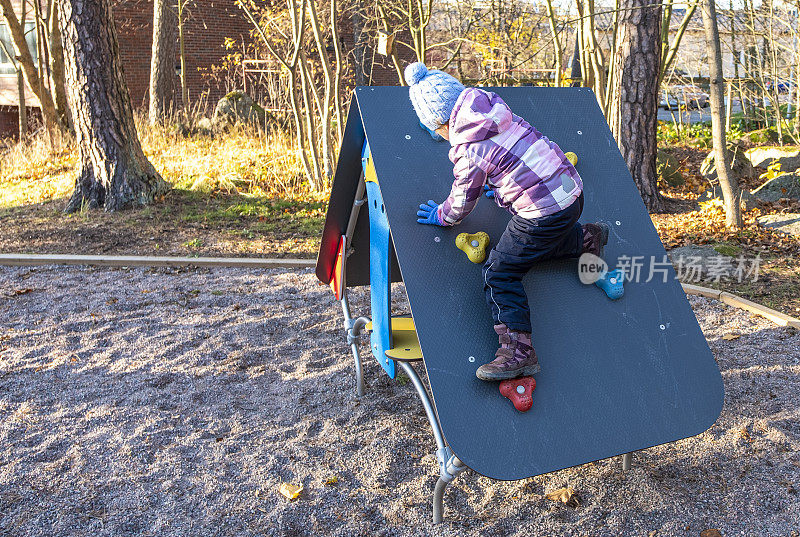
[0,267,800,537]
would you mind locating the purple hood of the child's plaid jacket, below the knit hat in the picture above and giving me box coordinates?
[450,88,513,146]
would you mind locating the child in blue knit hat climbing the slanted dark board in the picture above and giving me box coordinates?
[405,62,609,380]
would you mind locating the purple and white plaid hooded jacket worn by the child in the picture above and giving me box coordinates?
[438,88,583,226]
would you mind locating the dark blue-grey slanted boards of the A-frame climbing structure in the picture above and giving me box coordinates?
[317,87,723,479]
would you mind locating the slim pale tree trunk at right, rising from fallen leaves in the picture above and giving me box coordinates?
[703,0,742,228]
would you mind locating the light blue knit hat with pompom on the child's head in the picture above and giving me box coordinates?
[405,62,465,131]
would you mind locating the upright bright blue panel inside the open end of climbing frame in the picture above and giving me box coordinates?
[366,172,395,378]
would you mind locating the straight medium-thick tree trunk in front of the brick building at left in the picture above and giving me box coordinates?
[148,0,178,125]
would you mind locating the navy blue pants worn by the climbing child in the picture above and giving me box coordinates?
[483,193,583,332]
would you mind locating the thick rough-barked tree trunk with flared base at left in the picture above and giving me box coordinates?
[59,0,168,212]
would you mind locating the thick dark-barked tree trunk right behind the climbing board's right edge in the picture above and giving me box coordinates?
[608,0,663,212]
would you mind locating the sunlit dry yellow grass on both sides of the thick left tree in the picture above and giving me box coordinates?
[0,115,328,207]
